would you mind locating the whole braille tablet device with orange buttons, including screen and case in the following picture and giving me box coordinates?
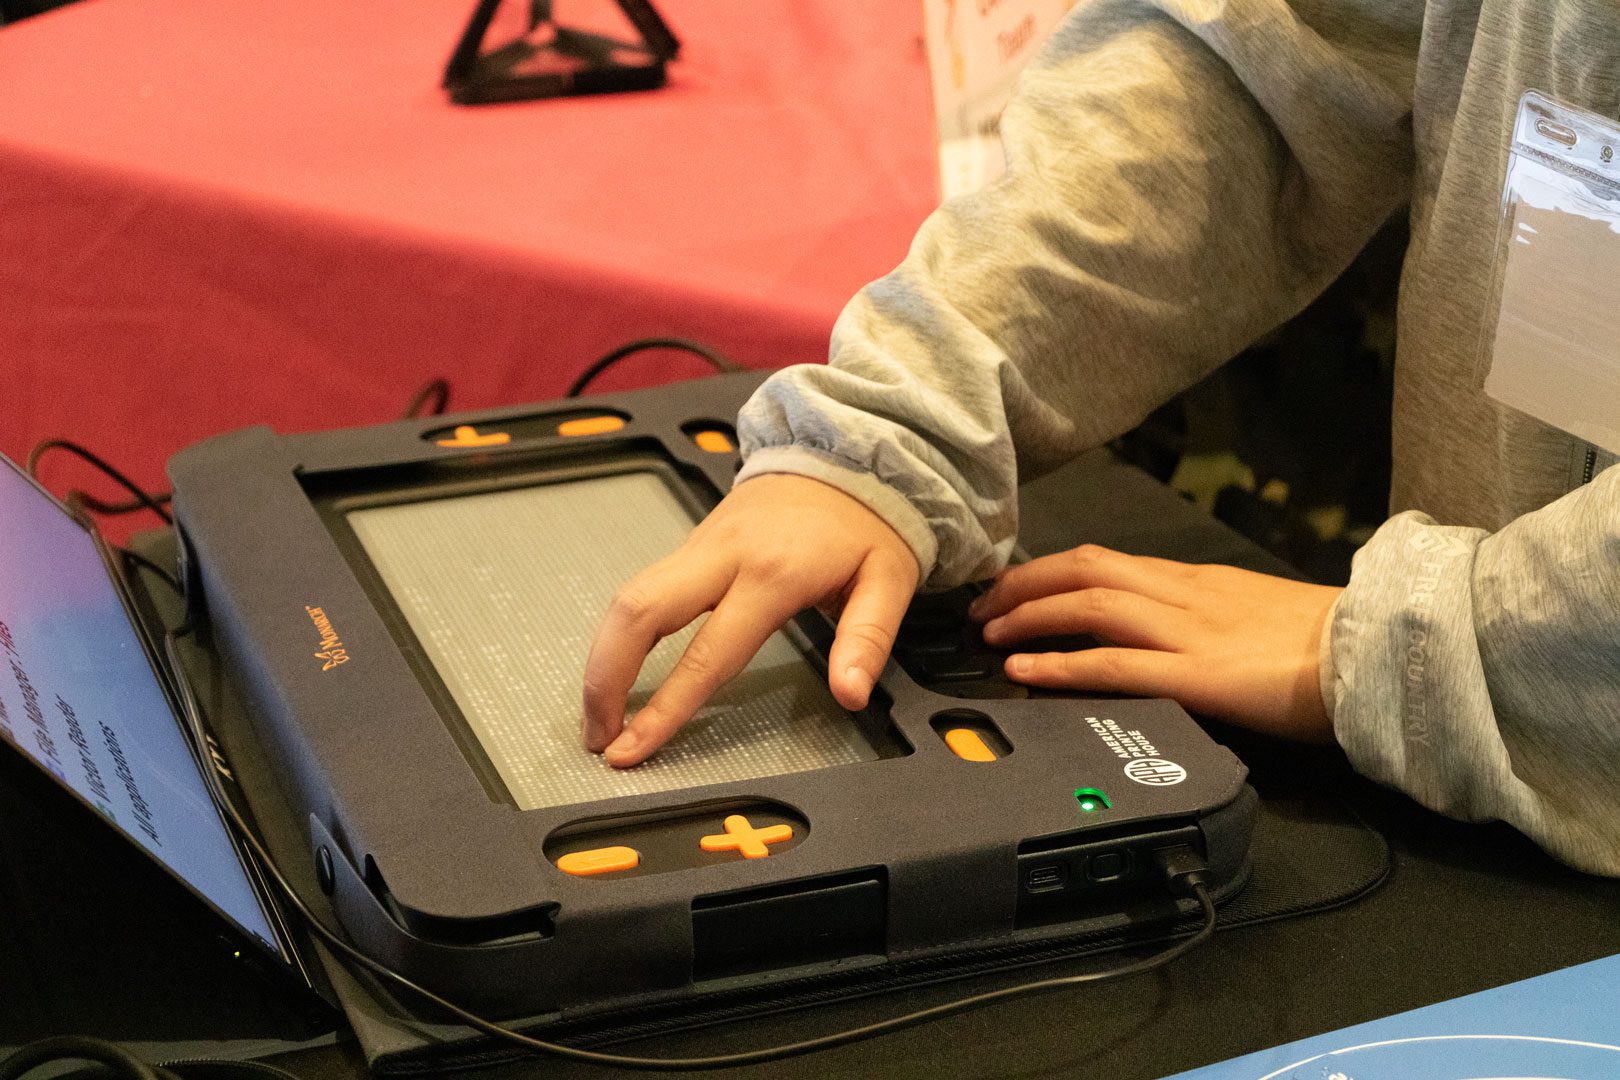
[170,372,1256,1020]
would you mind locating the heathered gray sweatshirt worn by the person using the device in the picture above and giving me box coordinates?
[740,0,1620,874]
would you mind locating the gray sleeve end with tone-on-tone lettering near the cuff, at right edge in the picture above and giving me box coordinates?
[1322,466,1620,874]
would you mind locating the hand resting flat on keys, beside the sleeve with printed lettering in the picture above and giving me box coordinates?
[970,546,1341,742]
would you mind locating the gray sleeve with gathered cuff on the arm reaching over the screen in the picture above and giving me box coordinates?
[739,0,1422,586]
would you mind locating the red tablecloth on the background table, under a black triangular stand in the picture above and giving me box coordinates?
[0,0,936,508]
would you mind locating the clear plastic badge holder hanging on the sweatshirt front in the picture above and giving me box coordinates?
[1479,91,1620,453]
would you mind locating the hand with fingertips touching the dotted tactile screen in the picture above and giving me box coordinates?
[585,474,919,766]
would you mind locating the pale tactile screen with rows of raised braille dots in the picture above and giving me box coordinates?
[348,471,878,810]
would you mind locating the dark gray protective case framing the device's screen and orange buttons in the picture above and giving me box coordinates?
[168,372,1256,1018]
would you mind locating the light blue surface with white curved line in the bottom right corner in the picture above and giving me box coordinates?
[1171,955,1620,1080]
